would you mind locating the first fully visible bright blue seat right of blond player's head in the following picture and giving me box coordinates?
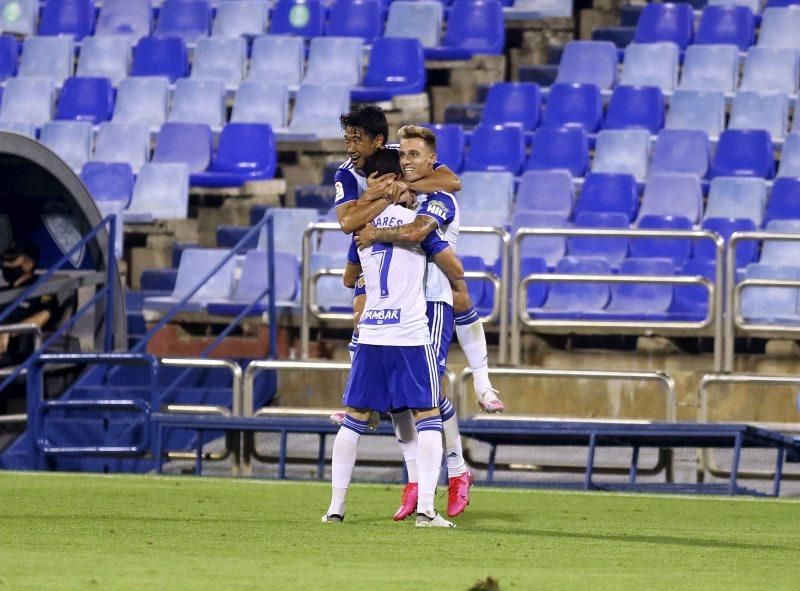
[464,125,525,174]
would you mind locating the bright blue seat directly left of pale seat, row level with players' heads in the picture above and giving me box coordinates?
[525,127,589,177]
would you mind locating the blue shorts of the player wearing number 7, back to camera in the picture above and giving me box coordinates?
[342,343,439,412]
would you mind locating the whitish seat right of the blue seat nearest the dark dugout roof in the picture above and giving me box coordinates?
[124,163,189,222]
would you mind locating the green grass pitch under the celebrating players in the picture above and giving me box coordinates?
[0,472,800,591]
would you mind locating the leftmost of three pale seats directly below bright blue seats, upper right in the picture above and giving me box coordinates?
[619,43,679,92]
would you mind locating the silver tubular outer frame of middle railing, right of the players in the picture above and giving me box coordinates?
[511,228,725,370]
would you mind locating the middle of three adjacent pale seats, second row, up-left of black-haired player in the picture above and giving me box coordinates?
[247,35,305,86]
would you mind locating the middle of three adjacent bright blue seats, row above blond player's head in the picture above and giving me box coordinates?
[542,84,603,133]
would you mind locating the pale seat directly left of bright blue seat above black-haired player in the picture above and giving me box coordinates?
[303,37,364,86]
